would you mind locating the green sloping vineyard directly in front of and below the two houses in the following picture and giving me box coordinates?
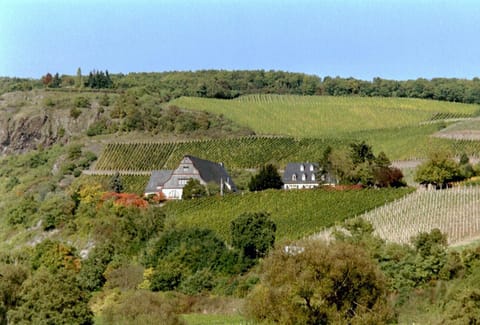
[165,188,412,240]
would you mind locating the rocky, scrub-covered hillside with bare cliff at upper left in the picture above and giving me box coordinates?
[0,89,253,154]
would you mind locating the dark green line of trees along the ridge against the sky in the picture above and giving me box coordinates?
[0,69,480,104]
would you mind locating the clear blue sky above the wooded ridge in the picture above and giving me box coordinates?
[0,0,480,80]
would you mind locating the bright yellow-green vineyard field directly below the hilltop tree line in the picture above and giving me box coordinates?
[171,95,478,137]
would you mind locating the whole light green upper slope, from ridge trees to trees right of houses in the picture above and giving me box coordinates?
[171,95,480,159]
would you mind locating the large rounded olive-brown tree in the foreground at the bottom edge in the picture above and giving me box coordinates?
[246,241,393,324]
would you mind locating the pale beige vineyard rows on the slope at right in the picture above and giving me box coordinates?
[362,186,480,244]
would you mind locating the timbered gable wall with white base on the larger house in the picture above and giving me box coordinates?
[162,157,206,200]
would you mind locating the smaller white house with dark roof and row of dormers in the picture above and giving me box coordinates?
[282,162,320,190]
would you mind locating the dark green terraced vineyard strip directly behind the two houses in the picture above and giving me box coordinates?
[95,137,353,171]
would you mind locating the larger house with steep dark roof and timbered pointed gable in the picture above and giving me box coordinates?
[145,155,237,199]
